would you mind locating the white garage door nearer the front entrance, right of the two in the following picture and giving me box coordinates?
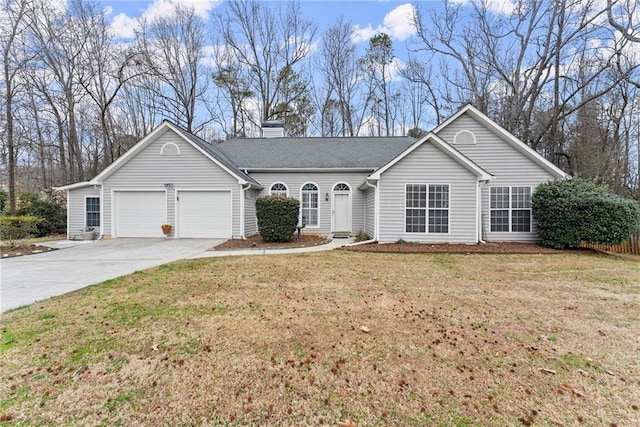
[178,191,231,239]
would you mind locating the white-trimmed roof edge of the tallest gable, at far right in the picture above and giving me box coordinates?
[432,104,569,179]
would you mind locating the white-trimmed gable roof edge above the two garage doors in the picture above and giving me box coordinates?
[90,120,261,187]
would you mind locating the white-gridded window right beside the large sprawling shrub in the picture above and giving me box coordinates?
[490,187,532,233]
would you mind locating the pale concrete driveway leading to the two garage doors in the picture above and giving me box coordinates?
[0,239,224,312]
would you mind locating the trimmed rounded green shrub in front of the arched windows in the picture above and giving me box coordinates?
[256,196,300,242]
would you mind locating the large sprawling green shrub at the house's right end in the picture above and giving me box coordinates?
[531,178,639,249]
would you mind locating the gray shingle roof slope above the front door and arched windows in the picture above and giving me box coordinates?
[216,136,416,170]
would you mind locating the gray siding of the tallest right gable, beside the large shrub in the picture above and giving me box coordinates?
[438,114,555,241]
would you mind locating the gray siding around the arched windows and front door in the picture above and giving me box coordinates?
[250,171,368,234]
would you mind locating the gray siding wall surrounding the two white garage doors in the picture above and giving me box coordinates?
[103,130,242,237]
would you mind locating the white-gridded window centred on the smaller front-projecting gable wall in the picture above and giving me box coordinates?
[405,184,449,233]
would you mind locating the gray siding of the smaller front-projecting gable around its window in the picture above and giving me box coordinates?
[378,142,478,243]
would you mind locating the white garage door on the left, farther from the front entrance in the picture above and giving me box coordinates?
[115,191,167,237]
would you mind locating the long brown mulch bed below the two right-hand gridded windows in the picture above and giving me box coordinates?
[343,242,566,254]
